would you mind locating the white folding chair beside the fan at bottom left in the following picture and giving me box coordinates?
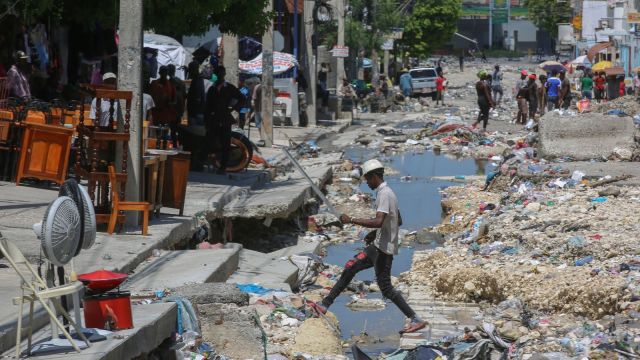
[0,236,91,358]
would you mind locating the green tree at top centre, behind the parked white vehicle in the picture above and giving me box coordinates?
[402,0,462,56]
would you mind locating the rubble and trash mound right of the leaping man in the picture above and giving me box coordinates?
[401,151,640,359]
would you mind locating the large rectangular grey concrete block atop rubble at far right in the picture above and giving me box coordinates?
[539,112,635,160]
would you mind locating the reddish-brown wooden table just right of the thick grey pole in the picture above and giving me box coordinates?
[147,150,191,216]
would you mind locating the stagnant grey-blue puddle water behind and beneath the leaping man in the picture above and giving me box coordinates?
[325,148,491,356]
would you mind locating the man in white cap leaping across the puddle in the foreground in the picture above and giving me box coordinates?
[310,159,428,334]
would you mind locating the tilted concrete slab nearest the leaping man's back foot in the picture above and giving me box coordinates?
[227,249,298,291]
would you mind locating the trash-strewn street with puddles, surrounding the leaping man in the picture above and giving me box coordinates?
[255,56,639,359]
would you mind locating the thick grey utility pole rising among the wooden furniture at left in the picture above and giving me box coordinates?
[118,0,143,226]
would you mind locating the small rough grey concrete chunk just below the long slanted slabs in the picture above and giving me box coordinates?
[171,282,249,306]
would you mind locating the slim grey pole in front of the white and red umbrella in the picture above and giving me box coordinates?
[260,0,273,147]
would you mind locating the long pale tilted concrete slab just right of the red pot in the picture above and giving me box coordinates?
[125,243,242,295]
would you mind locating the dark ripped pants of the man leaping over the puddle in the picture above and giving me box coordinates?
[322,244,416,318]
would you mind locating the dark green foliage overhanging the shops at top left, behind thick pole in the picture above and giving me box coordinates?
[0,0,273,37]
